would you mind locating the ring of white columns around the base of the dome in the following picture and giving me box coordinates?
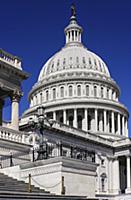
[47,108,128,137]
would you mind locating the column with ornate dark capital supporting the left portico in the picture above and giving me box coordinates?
[11,92,21,130]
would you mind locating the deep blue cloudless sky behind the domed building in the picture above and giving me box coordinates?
[0,0,131,134]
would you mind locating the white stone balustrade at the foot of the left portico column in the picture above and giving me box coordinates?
[0,126,29,144]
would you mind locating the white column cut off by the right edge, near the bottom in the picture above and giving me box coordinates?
[126,155,131,193]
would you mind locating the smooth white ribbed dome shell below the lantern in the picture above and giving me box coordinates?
[38,44,110,81]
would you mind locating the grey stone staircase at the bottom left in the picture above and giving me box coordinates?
[0,173,86,200]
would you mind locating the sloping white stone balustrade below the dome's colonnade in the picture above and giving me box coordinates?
[53,122,113,146]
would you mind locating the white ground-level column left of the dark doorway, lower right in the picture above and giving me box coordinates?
[112,157,120,194]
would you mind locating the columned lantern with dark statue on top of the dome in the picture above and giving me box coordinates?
[65,5,83,44]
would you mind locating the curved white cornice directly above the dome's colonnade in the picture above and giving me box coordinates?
[23,97,129,117]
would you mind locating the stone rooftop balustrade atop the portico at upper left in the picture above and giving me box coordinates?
[0,49,21,69]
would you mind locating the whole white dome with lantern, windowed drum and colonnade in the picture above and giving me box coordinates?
[24,5,128,141]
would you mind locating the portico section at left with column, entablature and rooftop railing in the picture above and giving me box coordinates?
[0,49,29,130]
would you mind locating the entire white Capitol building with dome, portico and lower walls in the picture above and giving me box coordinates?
[0,6,131,200]
